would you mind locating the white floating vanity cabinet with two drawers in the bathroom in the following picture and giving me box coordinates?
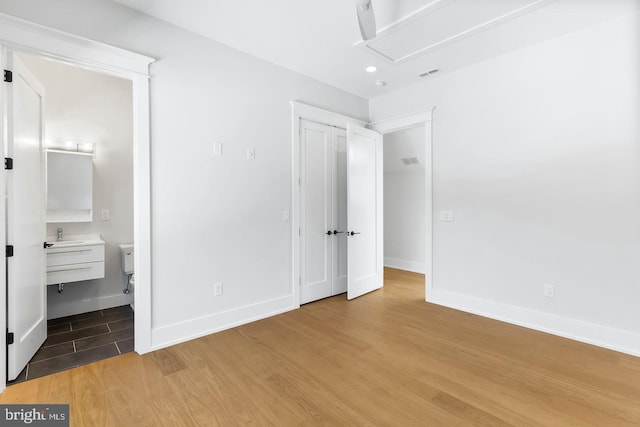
[47,238,104,285]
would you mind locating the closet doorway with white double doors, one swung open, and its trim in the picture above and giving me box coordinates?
[293,103,383,304]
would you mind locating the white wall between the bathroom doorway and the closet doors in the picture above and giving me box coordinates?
[0,0,368,348]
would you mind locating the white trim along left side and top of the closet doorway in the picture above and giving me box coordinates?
[290,101,367,308]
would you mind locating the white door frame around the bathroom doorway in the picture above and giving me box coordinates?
[0,14,155,392]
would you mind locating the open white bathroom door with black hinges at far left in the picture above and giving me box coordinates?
[5,52,47,381]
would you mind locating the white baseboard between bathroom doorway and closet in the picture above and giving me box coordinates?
[151,295,298,351]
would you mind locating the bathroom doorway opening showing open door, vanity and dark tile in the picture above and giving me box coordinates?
[6,51,134,384]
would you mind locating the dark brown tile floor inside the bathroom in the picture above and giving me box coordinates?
[9,305,133,384]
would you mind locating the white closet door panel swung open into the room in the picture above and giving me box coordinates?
[347,124,383,299]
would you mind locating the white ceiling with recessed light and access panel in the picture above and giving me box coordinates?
[114,0,640,98]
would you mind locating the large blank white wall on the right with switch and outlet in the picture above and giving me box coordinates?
[371,10,640,354]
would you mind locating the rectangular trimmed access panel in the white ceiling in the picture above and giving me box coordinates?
[364,0,550,62]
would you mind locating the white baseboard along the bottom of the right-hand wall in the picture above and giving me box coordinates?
[427,288,640,356]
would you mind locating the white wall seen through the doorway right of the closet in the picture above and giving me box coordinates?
[383,126,425,273]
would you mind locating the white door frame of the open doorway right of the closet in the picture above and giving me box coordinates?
[370,107,434,301]
